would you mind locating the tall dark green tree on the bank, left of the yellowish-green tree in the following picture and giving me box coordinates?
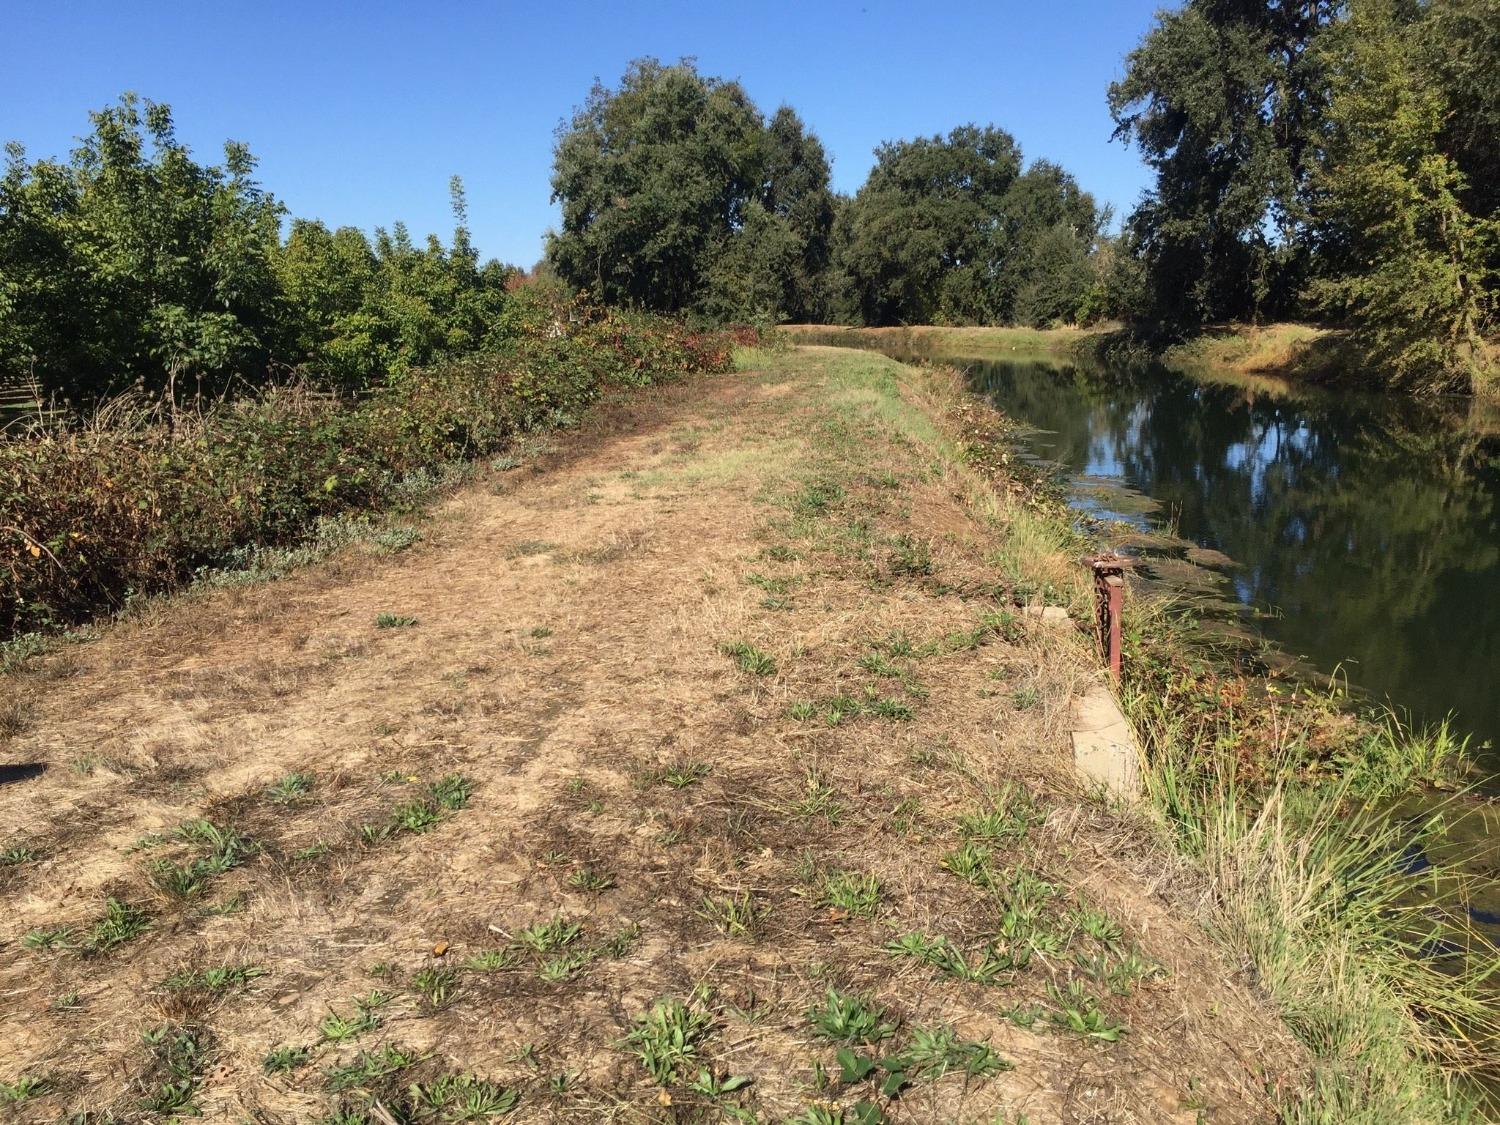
[1109,0,1340,330]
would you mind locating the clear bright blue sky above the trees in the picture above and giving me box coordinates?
[0,0,1160,266]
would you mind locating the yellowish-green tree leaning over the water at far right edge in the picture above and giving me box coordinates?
[1311,0,1497,390]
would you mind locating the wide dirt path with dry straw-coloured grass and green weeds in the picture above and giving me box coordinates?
[0,350,1298,1122]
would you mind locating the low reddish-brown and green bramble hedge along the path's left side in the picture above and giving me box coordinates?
[0,309,732,638]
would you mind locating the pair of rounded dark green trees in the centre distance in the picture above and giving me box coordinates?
[548,59,1113,334]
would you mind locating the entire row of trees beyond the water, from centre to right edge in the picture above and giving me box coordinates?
[548,0,1500,390]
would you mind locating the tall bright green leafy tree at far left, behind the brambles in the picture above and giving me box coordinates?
[0,95,282,396]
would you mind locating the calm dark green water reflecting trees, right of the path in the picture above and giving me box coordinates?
[834,334,1500,774]
